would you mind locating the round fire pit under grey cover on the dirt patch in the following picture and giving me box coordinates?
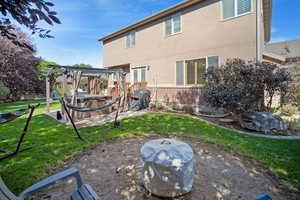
[140,139,194,197]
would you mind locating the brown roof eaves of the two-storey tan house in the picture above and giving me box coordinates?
[99,0,272,41]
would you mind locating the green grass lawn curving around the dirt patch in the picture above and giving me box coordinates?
[0,101,300,194]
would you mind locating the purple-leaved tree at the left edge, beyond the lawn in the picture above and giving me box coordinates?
[0,29,45,99]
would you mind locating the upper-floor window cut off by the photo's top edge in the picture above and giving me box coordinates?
[222,0,252,19]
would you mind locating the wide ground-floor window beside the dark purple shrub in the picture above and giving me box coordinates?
[176,56,219,85]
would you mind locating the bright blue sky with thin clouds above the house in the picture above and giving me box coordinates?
[24,0,300,67]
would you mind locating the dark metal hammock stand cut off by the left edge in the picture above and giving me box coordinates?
[0,104,41,161]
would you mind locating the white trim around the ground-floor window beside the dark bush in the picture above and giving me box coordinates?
[175,55,221,87]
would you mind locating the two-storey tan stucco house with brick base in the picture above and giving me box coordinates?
[99,0,272,108]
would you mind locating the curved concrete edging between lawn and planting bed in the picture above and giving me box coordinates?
[152,112,300,140]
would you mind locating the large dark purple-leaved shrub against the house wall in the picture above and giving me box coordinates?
[203,59,291,113]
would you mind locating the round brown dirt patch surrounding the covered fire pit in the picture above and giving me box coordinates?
[34,135,300,200]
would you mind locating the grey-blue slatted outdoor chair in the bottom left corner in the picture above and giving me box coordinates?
[0,168,101,200]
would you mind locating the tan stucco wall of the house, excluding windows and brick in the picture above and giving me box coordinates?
[103,0,256,86]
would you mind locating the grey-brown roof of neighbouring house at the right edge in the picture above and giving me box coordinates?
[265,39,300,58]
